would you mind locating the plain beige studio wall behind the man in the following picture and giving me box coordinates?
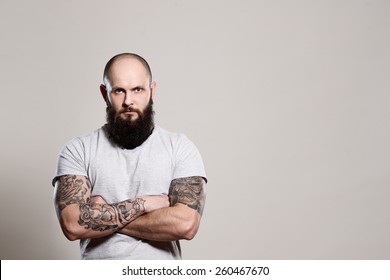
[0,0,390,259]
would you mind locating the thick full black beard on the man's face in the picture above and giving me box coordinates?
[105,99,154,150]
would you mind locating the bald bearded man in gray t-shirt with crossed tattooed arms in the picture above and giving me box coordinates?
[53,53,207,259]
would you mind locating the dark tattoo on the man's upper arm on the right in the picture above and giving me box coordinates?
[169,176,205,215]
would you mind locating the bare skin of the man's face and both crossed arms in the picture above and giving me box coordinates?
[55,56,205,241]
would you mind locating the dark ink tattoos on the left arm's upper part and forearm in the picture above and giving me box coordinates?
[56,175,145,231]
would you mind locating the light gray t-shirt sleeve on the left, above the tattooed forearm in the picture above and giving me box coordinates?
[52,138,87,186]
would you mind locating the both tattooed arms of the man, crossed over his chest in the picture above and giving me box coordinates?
[55,175,205,241]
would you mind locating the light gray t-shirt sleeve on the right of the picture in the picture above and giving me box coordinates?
[173,134,207,182]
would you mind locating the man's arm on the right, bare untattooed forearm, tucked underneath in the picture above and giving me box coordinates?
[119,176,205,241]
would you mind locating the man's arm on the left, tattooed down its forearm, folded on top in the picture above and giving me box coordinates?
[55,175,169,240]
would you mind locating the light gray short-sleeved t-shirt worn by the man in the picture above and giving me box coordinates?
[53,126,206,259]
